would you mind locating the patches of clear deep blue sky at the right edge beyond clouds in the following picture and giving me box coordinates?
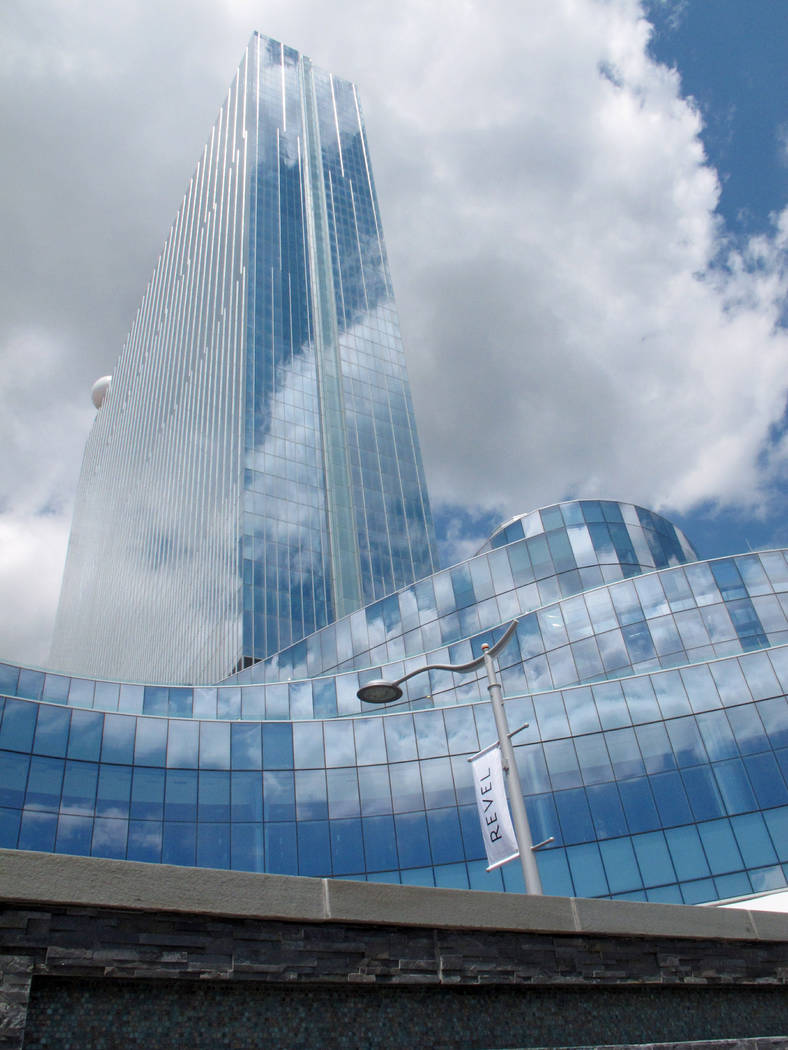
[647,0,788,558]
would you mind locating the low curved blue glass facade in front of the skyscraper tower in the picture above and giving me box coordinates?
[0,502,788,903]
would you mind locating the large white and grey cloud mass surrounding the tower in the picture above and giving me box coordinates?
[0,0,788,658]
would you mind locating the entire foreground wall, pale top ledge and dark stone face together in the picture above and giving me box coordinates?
[0,852,788,1050]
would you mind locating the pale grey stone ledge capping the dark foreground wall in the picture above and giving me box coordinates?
[0,849,788,942]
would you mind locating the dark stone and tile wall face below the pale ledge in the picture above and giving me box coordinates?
[0,905,788,1050]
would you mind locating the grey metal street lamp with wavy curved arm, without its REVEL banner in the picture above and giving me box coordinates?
[356,620,551,895]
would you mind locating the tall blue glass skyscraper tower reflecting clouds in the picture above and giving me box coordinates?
[51,34,437,681]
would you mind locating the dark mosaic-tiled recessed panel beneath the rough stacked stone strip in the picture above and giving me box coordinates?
[18,977,788,1050]
